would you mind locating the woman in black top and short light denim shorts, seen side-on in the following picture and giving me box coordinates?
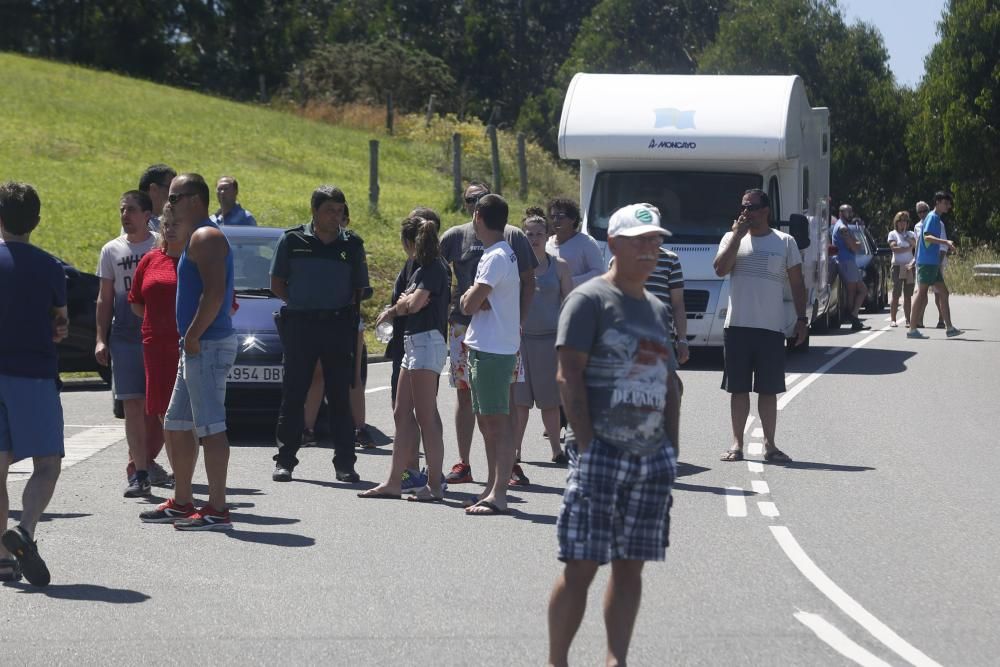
[358,217,451,502]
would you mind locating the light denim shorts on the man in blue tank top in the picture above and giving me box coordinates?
[163,334,237,438]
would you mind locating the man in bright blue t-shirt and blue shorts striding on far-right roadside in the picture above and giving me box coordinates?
[906,192,962,339]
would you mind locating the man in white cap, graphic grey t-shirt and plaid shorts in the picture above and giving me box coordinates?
[549,204,677,665]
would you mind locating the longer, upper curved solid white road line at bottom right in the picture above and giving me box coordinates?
[770,526,941,667]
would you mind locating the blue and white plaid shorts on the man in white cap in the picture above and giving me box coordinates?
[556,439,677,564]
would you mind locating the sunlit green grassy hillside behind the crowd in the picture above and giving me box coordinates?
[0,53,578,344]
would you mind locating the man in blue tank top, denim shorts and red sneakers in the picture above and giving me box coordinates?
[139,174,236,530]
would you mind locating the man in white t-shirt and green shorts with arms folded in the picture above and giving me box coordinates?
[460,194,521,516]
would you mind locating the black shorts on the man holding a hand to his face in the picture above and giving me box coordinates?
[722,327,785,394]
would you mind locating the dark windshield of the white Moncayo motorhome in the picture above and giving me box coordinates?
[587,171,763,243]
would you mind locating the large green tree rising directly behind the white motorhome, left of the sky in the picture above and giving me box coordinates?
[698,0,908,224]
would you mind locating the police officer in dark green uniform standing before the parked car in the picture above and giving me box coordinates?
[271,185,372,483]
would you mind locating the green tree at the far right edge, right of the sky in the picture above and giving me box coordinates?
[907,0,1000,242]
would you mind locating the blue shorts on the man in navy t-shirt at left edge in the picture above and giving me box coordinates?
[0,375,64,462]
